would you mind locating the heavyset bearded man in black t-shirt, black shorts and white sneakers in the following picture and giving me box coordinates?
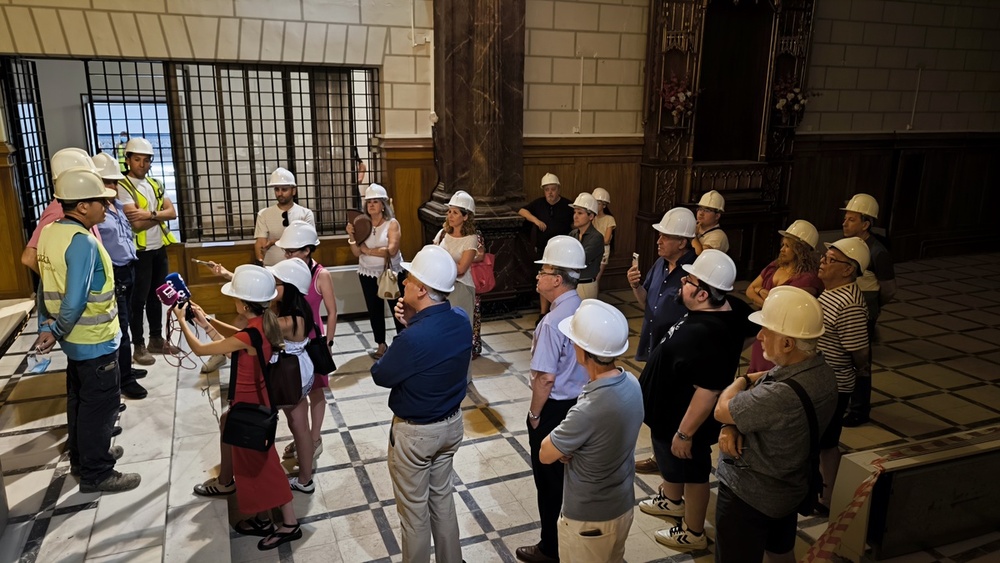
[639,249,754,549]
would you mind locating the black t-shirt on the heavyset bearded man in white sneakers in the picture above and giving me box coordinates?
[639,296,760,445]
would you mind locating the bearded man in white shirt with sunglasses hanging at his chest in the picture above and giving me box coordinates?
[253,167,316,266]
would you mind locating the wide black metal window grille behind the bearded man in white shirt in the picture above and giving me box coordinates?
[81,61,381,242]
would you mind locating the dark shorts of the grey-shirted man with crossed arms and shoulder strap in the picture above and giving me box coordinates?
[715,483,798,562]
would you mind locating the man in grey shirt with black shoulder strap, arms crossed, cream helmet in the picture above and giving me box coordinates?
[715,286,837,563]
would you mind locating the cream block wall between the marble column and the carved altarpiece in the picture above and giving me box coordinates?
[524,0,649,136]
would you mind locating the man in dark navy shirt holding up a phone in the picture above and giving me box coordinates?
[626,207,697,473]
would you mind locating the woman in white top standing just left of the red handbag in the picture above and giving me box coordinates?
[434,190,479,338]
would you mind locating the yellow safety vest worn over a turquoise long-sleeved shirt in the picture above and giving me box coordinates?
[38,222,119,344]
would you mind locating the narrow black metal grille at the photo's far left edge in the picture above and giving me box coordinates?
[0,58,53,235]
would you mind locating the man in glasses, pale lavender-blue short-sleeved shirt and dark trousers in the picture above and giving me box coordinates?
[517,235,589,563]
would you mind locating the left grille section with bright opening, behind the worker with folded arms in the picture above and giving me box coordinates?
[84,61,180,238]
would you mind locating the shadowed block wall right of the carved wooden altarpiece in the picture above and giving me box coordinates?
[799,0,1000,132]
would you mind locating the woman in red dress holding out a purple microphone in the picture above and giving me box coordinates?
[173,265,302,551]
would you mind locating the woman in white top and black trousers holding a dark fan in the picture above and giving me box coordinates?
[347,184,405,360]
